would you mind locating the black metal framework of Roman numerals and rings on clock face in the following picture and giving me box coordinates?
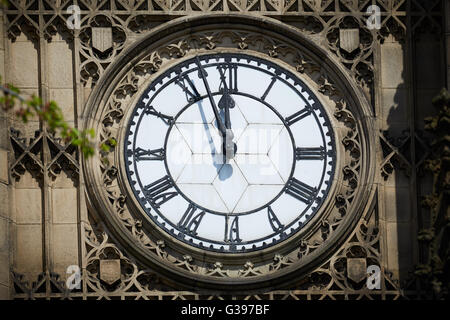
[124,53,336,253]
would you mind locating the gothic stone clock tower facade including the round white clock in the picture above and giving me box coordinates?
[0,0,450,300]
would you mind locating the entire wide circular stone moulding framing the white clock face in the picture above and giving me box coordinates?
[83,14,376,291]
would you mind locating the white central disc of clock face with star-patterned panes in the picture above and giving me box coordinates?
[167,96,293,214]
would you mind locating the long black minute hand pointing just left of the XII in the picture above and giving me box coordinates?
[195,57,237,162]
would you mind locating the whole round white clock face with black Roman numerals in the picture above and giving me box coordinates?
[125,54,335,253]
